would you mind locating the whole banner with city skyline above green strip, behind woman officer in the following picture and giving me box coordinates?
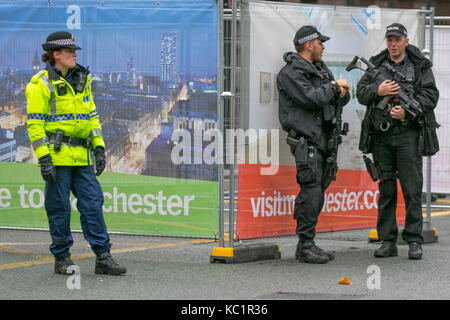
[0,0,218,237]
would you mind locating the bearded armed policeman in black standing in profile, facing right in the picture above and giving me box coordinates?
[277,26,350,263]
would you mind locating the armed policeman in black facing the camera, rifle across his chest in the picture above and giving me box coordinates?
[356,23,439,259]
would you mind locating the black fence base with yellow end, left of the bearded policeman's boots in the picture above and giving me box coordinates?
[210,243,281,263]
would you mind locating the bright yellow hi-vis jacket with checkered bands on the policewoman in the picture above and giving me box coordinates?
[26,65,105,166]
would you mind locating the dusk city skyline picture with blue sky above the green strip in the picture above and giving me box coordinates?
[0,1,217,180]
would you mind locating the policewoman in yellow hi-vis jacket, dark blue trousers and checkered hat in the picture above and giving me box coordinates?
[26,31,126,275]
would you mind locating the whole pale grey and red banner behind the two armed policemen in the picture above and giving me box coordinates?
[236,0,421,238]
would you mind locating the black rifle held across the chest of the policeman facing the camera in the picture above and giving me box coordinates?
[345,56,423,131]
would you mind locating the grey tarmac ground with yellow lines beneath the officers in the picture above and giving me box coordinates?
[0,211,450,300]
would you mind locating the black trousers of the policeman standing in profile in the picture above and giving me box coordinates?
[291,143,325,243]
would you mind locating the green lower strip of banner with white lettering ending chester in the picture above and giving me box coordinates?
[0,162,218,237]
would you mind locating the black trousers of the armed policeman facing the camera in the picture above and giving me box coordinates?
[373,127,423,243]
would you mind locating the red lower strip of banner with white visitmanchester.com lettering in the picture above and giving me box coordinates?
[236,164,405,239]
